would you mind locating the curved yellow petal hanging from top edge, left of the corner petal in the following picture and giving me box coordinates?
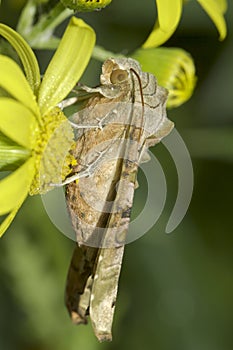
[142,0,183,48]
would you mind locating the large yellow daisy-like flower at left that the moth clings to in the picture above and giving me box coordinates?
[0,17,95,236]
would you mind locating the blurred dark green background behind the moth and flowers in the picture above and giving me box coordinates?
[0,0,233,350]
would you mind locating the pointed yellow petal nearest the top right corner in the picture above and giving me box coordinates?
[197,0,227,40]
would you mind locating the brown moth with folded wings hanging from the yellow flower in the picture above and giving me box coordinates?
[65,58,173,341]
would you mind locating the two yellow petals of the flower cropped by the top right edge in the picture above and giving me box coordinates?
[143,0,227,48]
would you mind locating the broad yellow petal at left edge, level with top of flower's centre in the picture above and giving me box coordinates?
[0,97,37,149]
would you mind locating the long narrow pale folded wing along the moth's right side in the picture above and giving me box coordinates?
[90,133,139,341]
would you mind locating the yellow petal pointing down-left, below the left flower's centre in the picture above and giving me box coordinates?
[0,158,34,215]
